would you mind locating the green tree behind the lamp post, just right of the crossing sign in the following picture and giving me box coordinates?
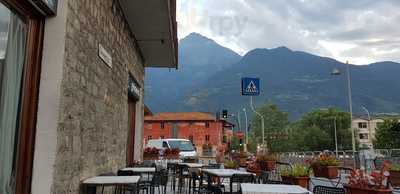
[251,102,289,152]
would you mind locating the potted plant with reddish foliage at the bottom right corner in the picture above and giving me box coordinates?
[344,162,392,194]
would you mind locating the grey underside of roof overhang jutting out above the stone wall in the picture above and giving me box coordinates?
[119,0,178,68]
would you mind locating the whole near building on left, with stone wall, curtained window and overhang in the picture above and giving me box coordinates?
[0,0,177,194]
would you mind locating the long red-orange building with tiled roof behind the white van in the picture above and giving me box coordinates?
[143,112,233,161]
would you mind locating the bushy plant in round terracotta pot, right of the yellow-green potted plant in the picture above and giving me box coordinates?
[311,153,339,179]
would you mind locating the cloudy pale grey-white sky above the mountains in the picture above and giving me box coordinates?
[177,0,400,65]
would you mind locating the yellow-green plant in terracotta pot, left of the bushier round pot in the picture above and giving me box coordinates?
[282,164,310,189]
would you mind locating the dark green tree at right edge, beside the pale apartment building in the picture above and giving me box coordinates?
[374,119,400,149]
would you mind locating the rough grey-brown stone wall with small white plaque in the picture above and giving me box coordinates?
[51,0,144,194]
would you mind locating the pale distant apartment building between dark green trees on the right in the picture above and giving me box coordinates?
[351,118,384,147]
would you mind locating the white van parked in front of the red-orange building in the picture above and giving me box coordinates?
[146,139,198,159]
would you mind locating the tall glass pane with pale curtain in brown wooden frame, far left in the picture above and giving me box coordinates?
[0,3,27,194]
